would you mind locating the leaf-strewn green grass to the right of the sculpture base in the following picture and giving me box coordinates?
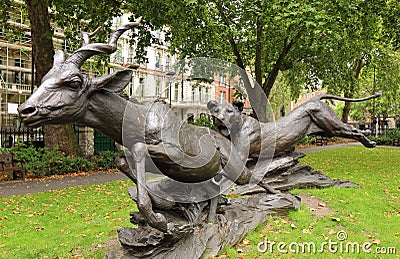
[220,147,400,258]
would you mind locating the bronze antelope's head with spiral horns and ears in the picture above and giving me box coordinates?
[18,18,141,127]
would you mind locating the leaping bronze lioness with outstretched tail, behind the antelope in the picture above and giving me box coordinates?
[207,92,382,161]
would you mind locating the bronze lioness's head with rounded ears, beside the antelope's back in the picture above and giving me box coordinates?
[207,101,243,137]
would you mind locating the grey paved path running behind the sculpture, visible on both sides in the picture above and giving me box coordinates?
[0,142,396,198]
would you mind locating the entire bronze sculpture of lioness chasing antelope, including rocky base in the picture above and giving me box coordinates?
[18,19,382,257]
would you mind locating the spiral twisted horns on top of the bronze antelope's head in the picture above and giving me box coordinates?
[66,17,142,67]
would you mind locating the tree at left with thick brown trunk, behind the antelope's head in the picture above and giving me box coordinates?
[0,0,122,155]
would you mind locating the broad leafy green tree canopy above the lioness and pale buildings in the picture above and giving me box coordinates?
[127,0,398,122]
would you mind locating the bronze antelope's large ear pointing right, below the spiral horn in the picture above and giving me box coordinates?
[91,70,132,93]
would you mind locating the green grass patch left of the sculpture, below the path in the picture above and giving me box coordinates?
[0,181,137,258]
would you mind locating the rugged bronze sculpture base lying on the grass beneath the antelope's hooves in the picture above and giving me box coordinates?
[107,193,300,259]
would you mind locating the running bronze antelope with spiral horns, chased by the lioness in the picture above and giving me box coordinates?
[18,18,249,232]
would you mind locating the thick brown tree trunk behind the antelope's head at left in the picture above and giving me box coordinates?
[25,0,79,155]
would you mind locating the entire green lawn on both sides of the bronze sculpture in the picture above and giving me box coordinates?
[0,147,400,258]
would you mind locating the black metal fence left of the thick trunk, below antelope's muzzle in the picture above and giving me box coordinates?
[0,127,44,148]
